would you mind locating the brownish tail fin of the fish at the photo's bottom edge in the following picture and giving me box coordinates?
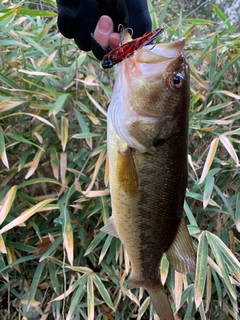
[147,285,174,320]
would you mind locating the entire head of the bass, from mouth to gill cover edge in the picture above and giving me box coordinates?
[109,39,190,152]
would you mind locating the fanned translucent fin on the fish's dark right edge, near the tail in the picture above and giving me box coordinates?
[166,217,196,273]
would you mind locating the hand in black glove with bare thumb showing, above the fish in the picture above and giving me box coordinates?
[57,0,151,60]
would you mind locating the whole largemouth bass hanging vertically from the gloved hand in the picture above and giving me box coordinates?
[102,33,195,320]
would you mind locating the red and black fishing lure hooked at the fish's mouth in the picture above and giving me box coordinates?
[101,25,164,69]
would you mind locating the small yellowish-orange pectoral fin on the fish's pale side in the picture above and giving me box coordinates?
[117,148,138,197]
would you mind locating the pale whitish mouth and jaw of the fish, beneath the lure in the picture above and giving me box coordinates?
[134,38,186,76]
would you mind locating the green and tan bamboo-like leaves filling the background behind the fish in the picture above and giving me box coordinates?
[0,0,240,320]
